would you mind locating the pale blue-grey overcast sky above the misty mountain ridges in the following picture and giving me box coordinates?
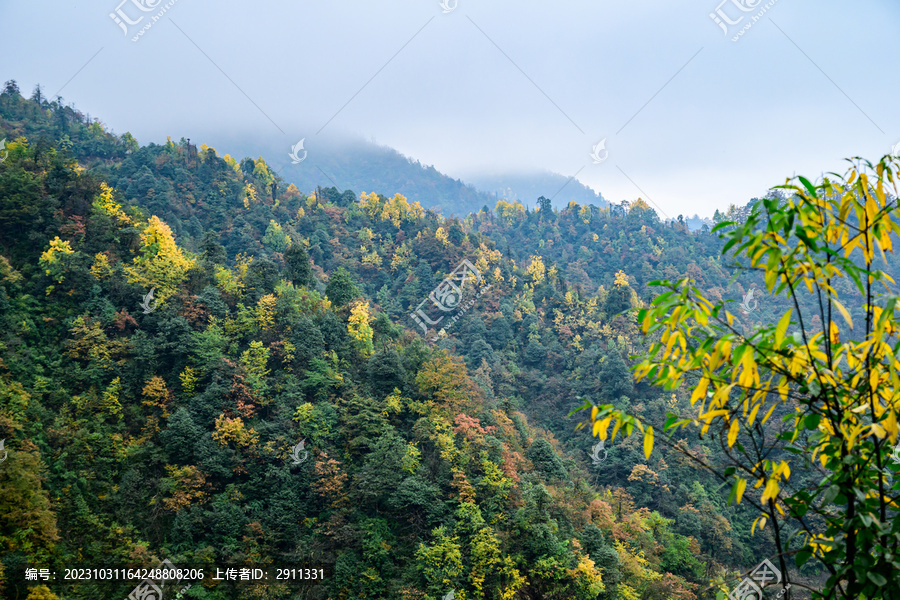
[0,0,900,216]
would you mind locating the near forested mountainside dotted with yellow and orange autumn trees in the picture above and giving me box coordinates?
[0,83,880,600]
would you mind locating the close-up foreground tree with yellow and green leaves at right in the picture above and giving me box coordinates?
[582,156,900,600]
